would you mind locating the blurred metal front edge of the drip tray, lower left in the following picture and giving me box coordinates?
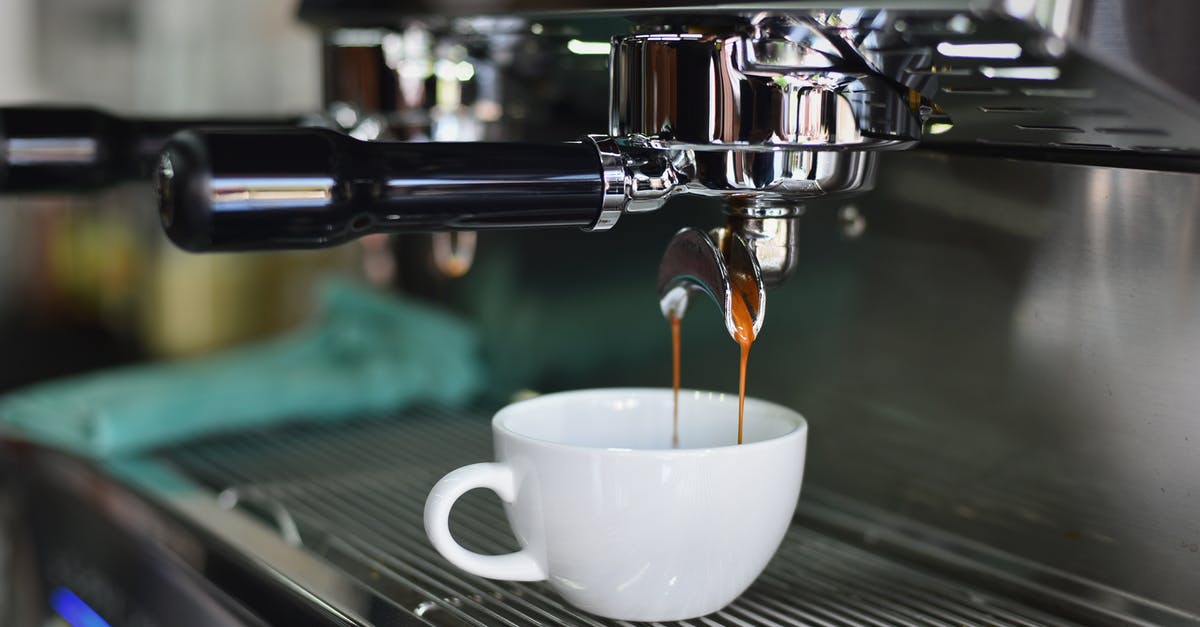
[0,438,427,627]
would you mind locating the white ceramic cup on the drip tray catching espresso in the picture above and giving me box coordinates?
[425,389,808,621]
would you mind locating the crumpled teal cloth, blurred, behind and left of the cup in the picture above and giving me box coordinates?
[0,282,486,458]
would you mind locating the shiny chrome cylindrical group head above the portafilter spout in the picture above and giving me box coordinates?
[610,26,920,150]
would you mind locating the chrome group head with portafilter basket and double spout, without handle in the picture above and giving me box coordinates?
[601,12,912,297]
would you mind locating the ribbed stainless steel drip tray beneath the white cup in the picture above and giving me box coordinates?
[150,410,1174,626]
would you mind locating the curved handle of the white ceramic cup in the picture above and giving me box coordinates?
[425,464,546,581]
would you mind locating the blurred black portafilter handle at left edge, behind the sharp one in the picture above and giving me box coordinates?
[0,106,300,193]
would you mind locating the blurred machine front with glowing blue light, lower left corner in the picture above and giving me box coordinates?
[0,437,362,627]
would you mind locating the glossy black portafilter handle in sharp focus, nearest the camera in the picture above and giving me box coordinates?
[157,129,604,251]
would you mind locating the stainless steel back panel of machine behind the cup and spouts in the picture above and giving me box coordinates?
[499,151,1200,615]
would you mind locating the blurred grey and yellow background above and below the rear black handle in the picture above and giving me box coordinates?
[0,0,356,392]
